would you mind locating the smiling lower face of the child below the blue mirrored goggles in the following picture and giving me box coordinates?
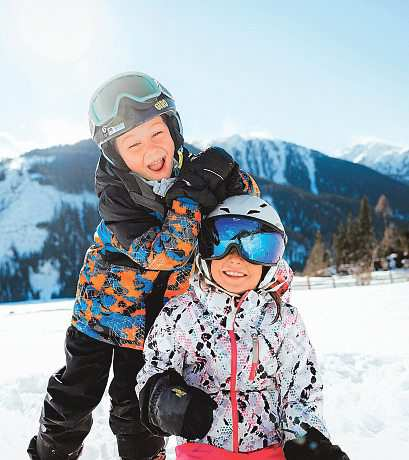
[210,249,263,294]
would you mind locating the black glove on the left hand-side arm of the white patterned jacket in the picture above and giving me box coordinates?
[139,369,217,440]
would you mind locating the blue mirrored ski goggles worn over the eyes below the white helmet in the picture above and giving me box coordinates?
[199,216,286,265]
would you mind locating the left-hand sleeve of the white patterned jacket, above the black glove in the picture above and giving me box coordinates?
[136,297,185,396]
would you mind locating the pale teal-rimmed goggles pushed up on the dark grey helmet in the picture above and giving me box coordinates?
[90,74,172,125]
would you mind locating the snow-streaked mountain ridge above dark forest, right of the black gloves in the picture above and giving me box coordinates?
[212,135,409,217]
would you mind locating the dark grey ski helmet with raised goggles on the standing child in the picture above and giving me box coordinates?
[88,72,183,170]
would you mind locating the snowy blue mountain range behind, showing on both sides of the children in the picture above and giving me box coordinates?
[0,136,409,301]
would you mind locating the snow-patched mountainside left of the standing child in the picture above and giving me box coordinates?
[0,142,98,300]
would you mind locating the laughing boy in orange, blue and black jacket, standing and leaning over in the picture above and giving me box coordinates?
[28,72,257,460]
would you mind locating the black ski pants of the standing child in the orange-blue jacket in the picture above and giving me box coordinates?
[31,326,165,460]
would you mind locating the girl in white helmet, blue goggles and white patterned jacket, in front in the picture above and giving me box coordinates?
[137,196,348,460]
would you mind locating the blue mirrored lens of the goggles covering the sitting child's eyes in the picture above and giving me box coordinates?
[205,217,285,265]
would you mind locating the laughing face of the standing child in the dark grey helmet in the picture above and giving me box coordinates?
[115,116,175,180]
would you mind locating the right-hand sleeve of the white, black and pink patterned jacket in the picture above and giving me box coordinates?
[277,304,328,441]
